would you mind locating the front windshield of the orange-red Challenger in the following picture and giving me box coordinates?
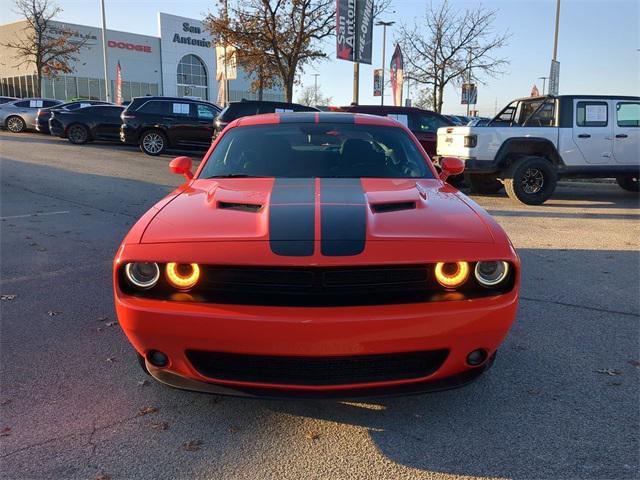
[200,123,433,178]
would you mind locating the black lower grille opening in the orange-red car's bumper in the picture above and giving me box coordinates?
[186,350,449,385]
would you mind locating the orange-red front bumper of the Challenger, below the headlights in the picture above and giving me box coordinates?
[116,287,518,397]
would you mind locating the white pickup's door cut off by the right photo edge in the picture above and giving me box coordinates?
[613,100,640,165]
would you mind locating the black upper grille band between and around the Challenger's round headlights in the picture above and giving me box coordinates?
[119,264,515,307]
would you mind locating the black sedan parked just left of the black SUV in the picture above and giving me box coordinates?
[49,105,124,144]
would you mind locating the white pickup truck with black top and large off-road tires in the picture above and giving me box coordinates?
[437,95,640,205]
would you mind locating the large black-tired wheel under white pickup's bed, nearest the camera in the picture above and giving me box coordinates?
[503,157,558,205]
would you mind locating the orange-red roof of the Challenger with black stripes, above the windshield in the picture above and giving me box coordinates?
[231,112,405,129]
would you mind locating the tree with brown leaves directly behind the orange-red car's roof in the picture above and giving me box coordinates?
[205,0,335,102]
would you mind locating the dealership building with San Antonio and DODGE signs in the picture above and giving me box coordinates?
[0,12,284,103]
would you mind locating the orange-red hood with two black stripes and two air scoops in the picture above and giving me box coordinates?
[141,178,494,246]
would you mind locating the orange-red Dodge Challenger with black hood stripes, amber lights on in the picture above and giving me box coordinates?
[113,112,520,397]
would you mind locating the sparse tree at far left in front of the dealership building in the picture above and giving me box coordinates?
[2,0,86,94]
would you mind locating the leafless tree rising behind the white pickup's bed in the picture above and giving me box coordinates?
[400,0,510,112]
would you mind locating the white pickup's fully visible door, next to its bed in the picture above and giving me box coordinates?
[573,98,613,165]
